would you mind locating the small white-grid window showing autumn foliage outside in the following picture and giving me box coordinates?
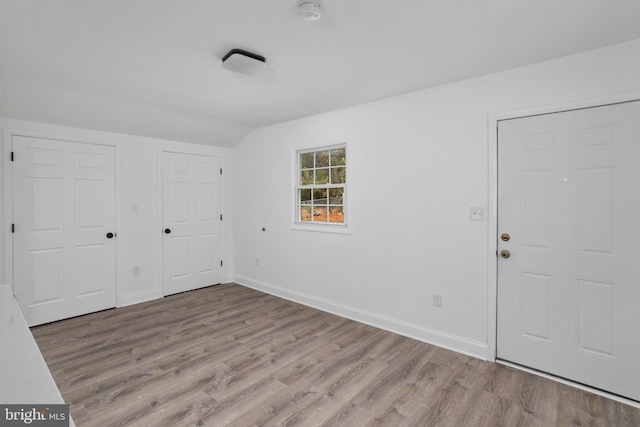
[296,145,347,225]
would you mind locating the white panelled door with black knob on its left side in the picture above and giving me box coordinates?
[162,153,223,295]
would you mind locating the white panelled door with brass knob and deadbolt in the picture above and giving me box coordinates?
[497,102,640,400]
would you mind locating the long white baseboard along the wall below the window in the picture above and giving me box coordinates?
[233,275,489,360]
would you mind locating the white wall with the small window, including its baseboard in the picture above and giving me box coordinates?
[233,36,640,359]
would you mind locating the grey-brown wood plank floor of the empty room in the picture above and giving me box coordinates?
[32,284,640,427]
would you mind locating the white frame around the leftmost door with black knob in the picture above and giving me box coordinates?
[0,128,122,307]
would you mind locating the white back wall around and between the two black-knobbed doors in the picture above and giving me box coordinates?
[0,119,233,305]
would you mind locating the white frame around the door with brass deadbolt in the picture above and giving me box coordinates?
[487,91,640,362]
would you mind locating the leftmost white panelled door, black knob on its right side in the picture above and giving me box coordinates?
[12,136,116,326]
